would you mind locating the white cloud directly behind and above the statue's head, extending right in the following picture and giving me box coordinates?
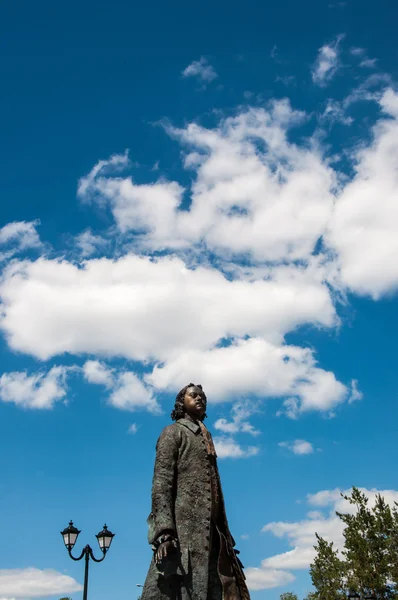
[148,338,347,416]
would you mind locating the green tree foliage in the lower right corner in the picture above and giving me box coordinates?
[308,487,398,600]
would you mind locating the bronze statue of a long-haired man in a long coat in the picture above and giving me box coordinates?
[141,383,250,600]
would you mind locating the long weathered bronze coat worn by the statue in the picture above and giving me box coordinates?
[141,419,241,600]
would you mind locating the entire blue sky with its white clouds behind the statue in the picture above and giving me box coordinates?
[0,0,398,600]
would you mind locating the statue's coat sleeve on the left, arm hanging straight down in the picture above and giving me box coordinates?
[149,425,180,544]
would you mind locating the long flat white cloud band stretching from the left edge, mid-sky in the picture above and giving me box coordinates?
[0,254,336,360]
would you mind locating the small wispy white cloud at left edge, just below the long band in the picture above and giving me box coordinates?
[0,366,68,410]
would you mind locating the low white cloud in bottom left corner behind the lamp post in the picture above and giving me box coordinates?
[0,567,83,600]
